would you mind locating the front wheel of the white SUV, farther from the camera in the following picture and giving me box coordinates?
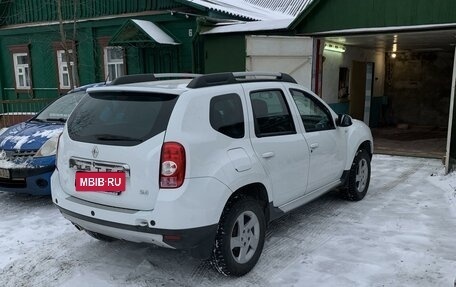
[344,149,371,201]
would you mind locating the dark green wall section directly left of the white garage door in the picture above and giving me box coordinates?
[203,34,246,73]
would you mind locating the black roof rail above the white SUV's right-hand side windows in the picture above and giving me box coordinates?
[187,72,297,89]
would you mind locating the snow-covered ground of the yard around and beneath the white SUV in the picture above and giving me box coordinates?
[0,155,456,287]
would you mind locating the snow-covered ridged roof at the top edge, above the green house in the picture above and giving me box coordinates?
[187,0,313,20]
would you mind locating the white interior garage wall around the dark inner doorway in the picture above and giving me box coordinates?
[321,46,385,104]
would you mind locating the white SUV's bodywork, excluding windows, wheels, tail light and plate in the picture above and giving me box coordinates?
[51,73,373,260]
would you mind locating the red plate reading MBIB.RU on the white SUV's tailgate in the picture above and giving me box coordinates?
[75,171,126,192]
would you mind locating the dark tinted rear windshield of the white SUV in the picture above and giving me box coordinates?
[68,92,178,146]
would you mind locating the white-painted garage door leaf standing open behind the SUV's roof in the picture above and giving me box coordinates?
[245,36,313,89]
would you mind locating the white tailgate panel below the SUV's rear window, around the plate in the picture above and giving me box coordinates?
[57,128,165,210]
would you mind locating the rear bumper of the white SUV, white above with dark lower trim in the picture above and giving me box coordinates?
[51,170,231,258]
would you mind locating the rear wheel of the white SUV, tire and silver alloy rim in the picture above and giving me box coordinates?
[211,197,266,276]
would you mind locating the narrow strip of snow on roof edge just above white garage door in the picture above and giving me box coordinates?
[201,18,293,34]
